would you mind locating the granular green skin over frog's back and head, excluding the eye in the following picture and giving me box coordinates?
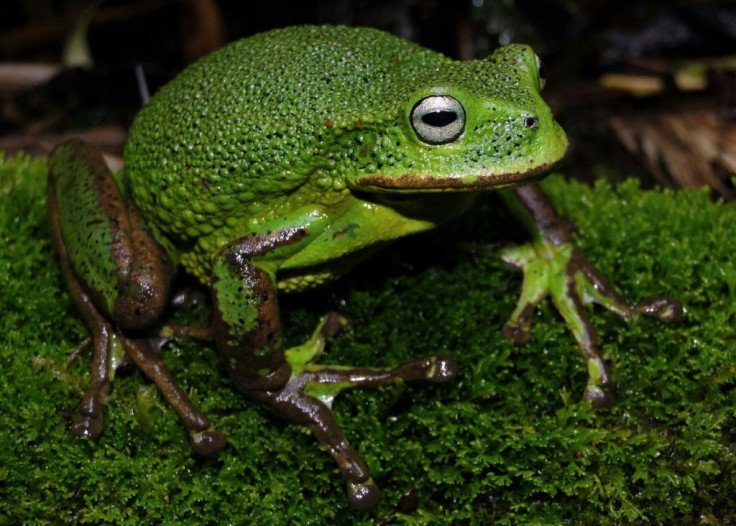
[125,27,564,280]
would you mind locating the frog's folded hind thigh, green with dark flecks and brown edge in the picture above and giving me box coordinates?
[49,140,175,329]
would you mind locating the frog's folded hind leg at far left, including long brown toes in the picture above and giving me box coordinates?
[48,140,225,454]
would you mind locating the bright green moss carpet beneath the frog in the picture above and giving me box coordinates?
[0,152,736,524]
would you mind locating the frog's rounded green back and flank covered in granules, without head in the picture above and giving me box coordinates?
[125,26,449,243]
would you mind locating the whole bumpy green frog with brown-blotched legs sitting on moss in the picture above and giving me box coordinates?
[48,26,682,509]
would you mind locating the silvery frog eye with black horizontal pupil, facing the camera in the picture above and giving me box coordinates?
[410,95,465,144]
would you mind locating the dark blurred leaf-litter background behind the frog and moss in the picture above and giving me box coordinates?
[0,0,736,198]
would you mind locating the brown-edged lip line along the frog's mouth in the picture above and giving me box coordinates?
[355,160,561,192]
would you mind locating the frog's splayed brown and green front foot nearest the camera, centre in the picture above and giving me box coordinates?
[248,314,457,509]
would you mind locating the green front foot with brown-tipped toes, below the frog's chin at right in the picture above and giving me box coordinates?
[501,239,682,407]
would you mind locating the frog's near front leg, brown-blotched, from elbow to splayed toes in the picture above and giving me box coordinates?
[212,233,456,509]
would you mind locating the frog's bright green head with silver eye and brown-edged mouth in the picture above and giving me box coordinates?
[347,44,568,192]
